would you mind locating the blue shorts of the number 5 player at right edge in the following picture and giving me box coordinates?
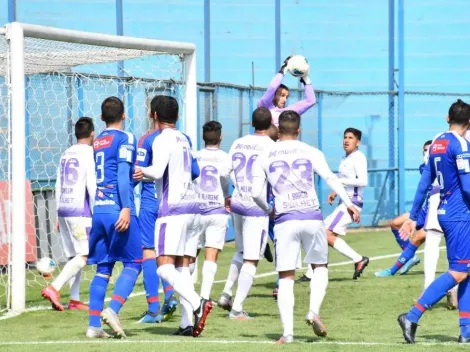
[439,221,470,273]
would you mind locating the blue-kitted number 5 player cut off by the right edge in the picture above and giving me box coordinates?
[398,99,470,344]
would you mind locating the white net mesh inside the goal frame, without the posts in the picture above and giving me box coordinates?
[0,31,185,311]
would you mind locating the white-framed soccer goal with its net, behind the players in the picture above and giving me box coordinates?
[0,23,197,313]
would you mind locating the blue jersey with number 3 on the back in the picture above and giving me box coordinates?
[93,129,137,215]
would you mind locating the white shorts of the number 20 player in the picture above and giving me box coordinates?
[232,213,269,260]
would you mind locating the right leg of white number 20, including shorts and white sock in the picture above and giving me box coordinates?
[229,216,269,320]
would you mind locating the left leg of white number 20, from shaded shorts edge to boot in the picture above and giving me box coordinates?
[217,213,243,311]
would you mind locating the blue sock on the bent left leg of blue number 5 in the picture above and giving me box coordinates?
[406,272,457,323]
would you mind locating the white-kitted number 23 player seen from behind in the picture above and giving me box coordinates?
[252,111,360,343]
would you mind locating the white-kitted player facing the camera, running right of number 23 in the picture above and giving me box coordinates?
[325,127,369,280]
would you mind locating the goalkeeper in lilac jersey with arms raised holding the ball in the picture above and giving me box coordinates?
[258,55,317,126]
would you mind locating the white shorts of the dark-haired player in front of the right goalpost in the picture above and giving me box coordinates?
[155,214,194,257]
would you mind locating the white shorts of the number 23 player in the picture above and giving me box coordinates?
[274,220,328,272]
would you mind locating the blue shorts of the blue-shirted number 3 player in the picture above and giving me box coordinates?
[88,214,143,264]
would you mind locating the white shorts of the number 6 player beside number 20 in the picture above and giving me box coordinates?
[199,214,228,251]
